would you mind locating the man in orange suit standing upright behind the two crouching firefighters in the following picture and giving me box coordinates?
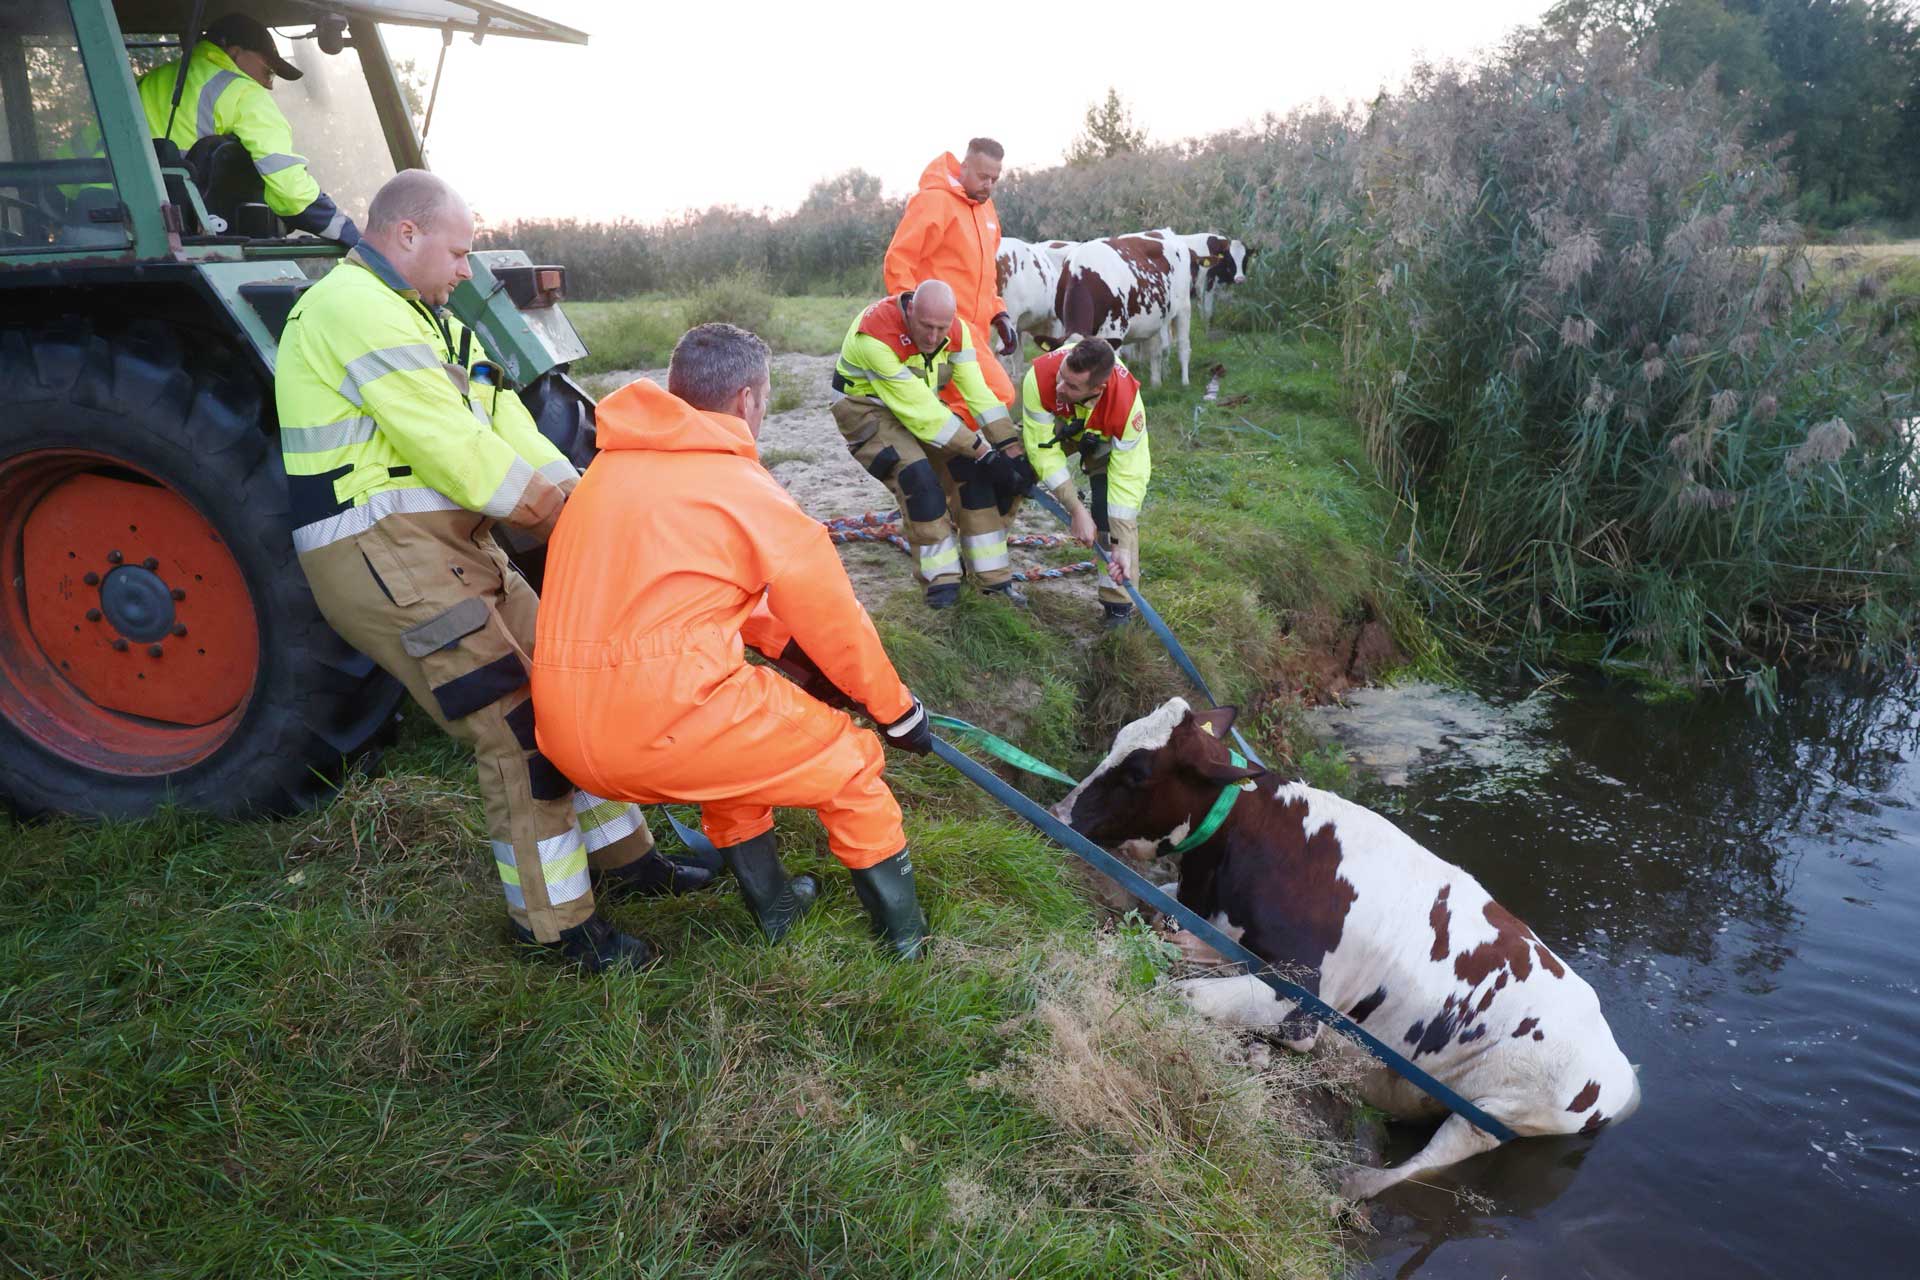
[883,138,1020,416]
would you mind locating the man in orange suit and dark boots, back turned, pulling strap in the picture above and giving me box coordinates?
[534,324,931,958]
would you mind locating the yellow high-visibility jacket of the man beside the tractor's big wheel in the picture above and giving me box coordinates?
[273,244,580,551]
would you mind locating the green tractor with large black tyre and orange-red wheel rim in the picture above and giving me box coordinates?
[0,0,593,818]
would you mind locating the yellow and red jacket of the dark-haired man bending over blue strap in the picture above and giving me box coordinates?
[1020,342,1154,520]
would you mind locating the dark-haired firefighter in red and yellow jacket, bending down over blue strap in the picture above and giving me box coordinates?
[1020,338,1154,626]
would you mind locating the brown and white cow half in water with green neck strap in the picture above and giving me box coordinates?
[1054,699,1640,1199]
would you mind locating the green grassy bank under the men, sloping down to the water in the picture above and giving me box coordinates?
[0,299,1417,1278]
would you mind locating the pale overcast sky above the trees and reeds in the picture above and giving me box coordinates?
[388,0,1548,223]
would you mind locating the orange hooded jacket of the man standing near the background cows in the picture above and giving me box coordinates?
[883,152,1006,333]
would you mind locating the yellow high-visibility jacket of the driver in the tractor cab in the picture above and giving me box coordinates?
[140,40,359,244]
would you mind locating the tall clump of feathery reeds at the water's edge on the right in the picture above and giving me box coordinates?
[1342,25,1920,677]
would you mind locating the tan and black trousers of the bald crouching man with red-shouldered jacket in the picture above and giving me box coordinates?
[833,397,1018,587]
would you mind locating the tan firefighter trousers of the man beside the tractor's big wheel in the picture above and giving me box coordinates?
[300,510,653,942]
